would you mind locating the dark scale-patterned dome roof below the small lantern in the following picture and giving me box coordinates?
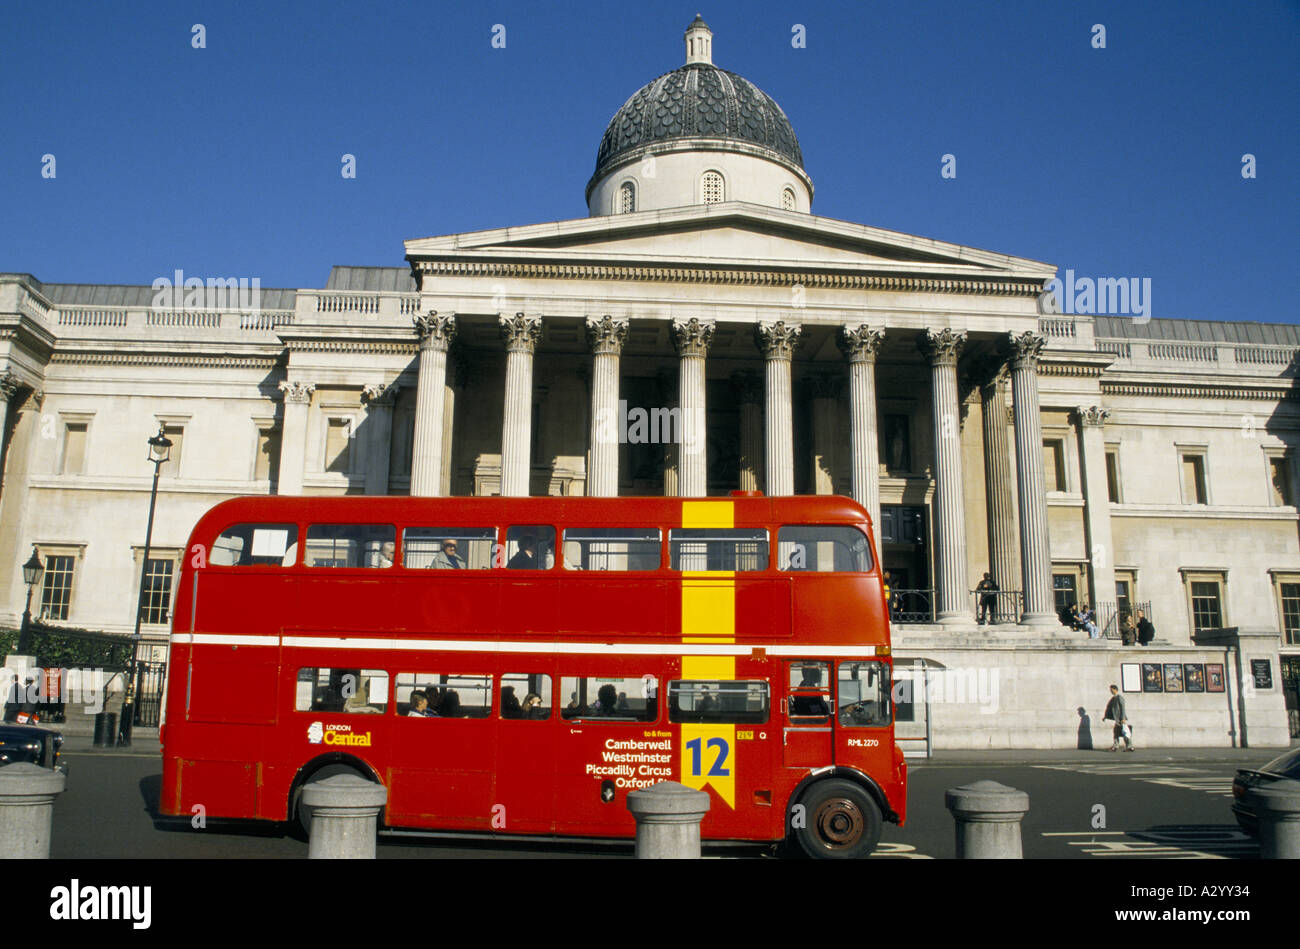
[592,62,803,181]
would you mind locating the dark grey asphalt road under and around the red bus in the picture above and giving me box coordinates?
[51,749,1274,861]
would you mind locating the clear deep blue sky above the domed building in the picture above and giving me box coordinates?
[0,0,1300,322]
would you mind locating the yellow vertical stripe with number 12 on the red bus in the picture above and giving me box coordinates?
[681,501,736,810]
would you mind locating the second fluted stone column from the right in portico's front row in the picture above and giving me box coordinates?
[917,329,974,624]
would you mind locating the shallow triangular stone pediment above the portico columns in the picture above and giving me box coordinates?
[406,202,1056,281]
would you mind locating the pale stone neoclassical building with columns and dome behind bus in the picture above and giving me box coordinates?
[0,18,1300,748]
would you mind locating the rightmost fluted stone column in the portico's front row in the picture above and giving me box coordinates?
[1010,332,1060,629]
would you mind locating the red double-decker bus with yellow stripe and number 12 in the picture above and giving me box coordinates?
[161,494,906,857]
